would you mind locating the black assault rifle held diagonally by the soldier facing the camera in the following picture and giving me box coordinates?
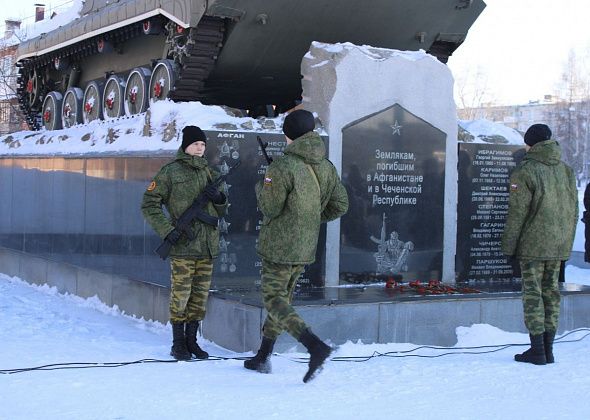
[156,160,240,260]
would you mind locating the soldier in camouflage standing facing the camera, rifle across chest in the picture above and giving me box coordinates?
[141,126,227,360]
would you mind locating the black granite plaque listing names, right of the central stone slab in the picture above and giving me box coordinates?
[455,143,524,281]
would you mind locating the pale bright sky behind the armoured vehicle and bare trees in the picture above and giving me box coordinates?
[0,0,590,104]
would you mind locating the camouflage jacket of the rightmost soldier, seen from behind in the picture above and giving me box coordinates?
[502,140,578,260]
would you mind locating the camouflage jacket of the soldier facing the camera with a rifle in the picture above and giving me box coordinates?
[141,149,227,258]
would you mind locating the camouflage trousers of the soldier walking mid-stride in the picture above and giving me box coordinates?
[262,260,307,340]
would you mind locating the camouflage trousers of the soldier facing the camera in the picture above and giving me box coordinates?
[170,258,213,322]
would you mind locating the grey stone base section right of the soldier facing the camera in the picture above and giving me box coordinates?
[203,280,590,352]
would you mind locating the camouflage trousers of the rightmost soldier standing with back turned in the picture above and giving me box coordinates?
[520,260,561,335]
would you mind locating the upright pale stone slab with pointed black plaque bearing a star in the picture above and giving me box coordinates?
[302,43,457,285]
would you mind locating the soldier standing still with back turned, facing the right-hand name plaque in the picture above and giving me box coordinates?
[502,124,578,365]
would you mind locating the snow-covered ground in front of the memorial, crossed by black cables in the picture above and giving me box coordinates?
[0,274,590,420]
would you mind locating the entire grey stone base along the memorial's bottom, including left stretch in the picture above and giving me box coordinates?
[0,247,590,352]
